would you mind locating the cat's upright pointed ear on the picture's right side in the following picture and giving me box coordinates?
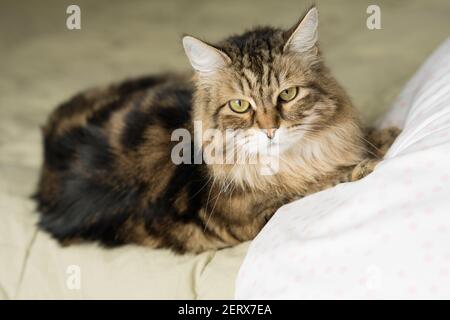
[283,7,319,53]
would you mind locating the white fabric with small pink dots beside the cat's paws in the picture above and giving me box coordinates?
[235,38,450,299]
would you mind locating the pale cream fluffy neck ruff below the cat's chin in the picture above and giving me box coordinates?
[208,125,365,194]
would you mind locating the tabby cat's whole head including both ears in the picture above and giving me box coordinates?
[183,7,359,182]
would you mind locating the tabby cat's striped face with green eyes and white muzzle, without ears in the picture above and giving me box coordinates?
[190,40,336,159]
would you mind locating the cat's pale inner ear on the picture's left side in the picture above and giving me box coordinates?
[183,36,230,73]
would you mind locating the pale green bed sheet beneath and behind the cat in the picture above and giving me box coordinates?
[0,0,450,299]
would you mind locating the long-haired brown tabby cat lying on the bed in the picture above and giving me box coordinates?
[35,7,400,253]
